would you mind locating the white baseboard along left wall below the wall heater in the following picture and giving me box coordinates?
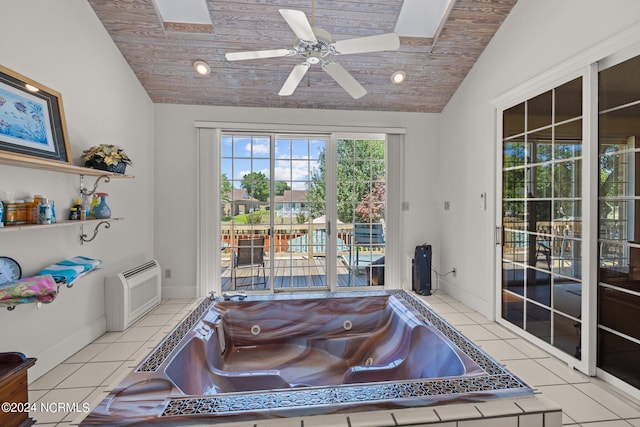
[29,316,107,383]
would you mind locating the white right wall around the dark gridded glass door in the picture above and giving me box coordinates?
[439,0,640,317]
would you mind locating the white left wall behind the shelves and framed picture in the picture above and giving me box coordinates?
[0,0,154,381]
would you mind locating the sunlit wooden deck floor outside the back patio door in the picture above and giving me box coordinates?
[222,256,378,290]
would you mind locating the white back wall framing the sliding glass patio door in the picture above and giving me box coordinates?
[155,104,439,298]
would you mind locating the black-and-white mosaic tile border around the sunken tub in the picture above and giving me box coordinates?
[150,290,532,417]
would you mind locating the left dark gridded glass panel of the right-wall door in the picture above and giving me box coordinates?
[500,78,582,359]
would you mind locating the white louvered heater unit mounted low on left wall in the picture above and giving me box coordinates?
[104,260,161,331]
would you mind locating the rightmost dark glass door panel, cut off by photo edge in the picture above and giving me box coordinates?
[597,57,640,388]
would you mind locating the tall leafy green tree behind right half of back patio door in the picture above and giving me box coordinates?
[307,139,385,222]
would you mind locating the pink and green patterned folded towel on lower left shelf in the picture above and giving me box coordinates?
[0,274,58,306]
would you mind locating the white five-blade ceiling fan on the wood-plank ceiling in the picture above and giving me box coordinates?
[225,9,400,99]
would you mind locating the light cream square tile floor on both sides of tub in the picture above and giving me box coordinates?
[29,292,640,427]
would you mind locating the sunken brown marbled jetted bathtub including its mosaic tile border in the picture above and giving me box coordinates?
[81,291,532,425]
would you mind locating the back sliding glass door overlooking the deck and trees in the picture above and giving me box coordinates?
[220,132,386,292]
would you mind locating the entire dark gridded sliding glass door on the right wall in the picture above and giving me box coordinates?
[497,52,640,394]
